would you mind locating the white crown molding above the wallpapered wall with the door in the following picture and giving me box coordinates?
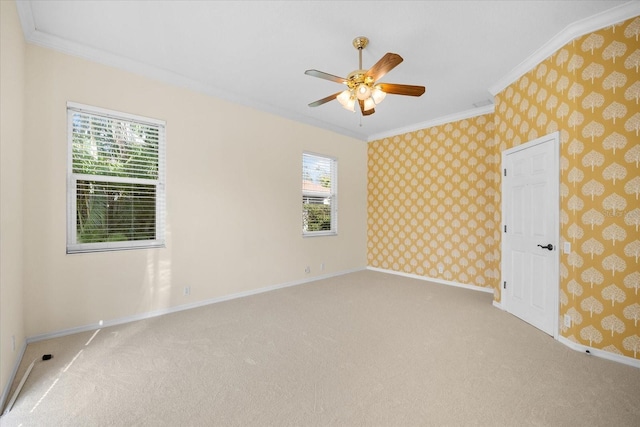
[489,0,640,96]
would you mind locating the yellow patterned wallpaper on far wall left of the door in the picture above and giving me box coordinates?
[367,114,500,288]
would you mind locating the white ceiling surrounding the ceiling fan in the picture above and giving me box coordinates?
[17,0,638,140]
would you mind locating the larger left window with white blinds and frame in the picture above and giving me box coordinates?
[67,103,165,253]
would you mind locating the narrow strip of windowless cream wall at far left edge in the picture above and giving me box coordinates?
[0,1,26,404]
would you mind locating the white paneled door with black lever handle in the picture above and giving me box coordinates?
[502,132,560,337]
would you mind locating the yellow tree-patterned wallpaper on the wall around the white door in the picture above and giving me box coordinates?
[495,17,640,359]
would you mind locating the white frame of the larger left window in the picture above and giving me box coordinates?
[66,102,166,254]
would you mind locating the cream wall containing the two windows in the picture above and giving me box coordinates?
[24,45,366,337]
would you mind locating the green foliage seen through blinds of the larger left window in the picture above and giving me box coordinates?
[72,113,159,243]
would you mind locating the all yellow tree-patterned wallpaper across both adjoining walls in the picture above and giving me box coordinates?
[367,17,640,359]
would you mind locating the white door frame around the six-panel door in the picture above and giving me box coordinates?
[500,131,561,340]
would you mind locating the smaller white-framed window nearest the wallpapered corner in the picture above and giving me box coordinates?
[302,153,338,236]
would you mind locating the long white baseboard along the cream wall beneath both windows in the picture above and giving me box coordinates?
[27,268,364,346]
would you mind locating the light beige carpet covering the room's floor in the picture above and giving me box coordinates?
[0,271,640,427]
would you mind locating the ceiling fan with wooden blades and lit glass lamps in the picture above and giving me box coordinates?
[304,36,425,116]
